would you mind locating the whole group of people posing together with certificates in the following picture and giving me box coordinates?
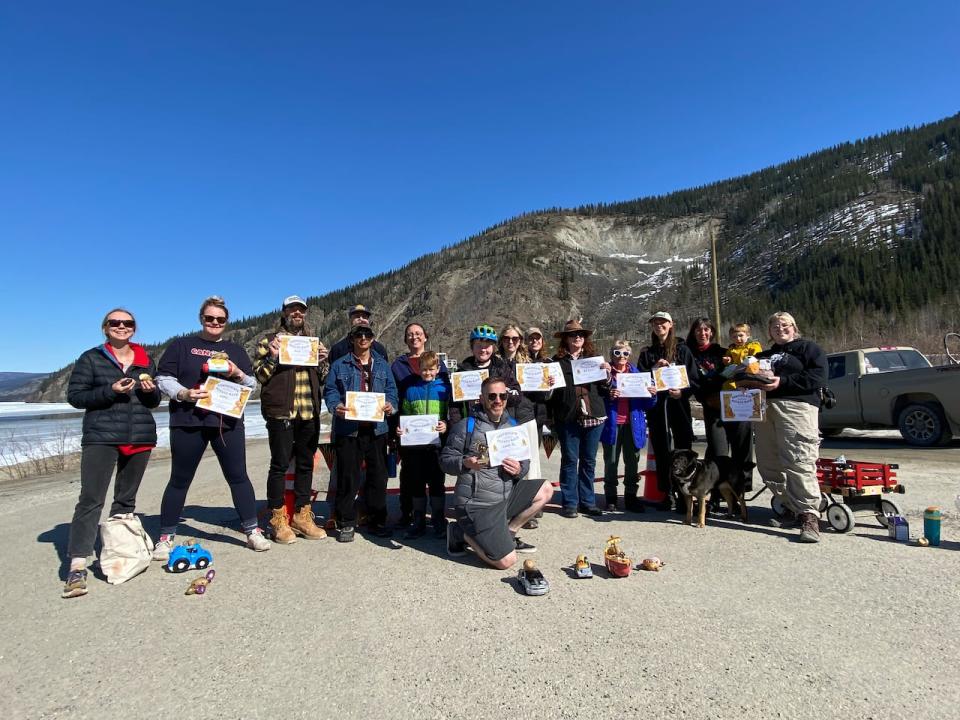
[62,295,826,597]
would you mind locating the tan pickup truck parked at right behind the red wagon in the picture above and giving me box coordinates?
[820,347,960,447]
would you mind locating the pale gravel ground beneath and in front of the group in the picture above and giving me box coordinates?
[0,435,960,720]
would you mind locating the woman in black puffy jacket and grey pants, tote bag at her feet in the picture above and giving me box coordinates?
[62,308,160,598]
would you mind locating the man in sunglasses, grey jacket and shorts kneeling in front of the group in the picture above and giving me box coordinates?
[440,378,553,570]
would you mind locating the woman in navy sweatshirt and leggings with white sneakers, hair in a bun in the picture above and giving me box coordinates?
[153,295,270,561]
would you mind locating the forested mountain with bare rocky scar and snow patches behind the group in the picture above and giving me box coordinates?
[34,114,960,400]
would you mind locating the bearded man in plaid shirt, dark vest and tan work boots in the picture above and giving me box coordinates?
[253,295,330,545]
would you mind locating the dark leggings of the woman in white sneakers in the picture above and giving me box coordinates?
[160,425,257,535]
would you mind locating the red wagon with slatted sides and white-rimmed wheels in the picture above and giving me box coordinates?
[770,455,905,533]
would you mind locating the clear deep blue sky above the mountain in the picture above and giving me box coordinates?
[0,0,960,371]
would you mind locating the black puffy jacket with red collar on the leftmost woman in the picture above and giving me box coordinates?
[67,345,160,445]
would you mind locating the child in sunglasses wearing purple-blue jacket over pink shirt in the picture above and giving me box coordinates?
[600,340,657,512]
